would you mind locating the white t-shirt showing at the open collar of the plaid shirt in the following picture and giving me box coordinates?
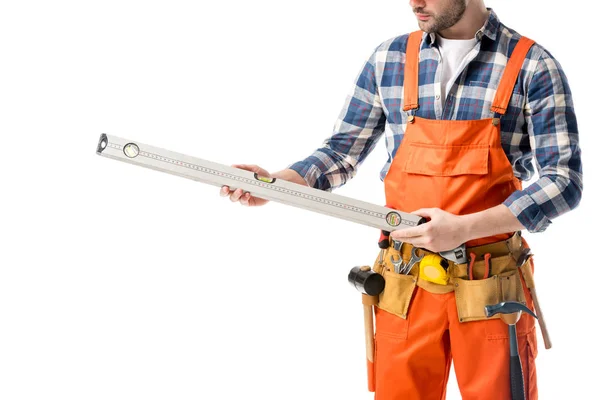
[435,35,477,104]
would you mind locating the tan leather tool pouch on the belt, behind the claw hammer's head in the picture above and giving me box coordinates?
[451,254,525,322]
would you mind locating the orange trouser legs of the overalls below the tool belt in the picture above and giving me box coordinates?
[375,287,538,400]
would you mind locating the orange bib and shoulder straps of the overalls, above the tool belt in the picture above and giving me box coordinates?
[384,31,531,246]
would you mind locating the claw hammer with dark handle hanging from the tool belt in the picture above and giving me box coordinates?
[485,301,537,400]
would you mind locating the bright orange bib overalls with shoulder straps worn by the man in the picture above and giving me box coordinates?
[374,31,537,400]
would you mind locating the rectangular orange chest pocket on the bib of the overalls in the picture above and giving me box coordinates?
[403,143,489,176]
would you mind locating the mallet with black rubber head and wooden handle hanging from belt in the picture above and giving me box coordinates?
[348,266,385,392]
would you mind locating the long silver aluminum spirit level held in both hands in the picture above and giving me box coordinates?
[96,134,466,263]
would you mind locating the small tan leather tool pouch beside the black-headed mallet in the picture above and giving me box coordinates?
[373,247,418,319]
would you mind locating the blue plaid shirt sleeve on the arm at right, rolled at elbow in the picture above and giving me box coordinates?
[504,52,583,232]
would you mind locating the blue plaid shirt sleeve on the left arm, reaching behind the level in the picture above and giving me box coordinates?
[287,50,386,191]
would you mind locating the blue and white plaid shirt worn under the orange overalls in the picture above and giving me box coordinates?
[288,9,583,232]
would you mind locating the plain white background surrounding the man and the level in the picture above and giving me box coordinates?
[0,0,600,400]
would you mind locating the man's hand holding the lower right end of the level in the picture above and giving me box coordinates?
[390,208,468,253]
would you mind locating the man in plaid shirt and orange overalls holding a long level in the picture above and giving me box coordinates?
[221,0,583,400]
